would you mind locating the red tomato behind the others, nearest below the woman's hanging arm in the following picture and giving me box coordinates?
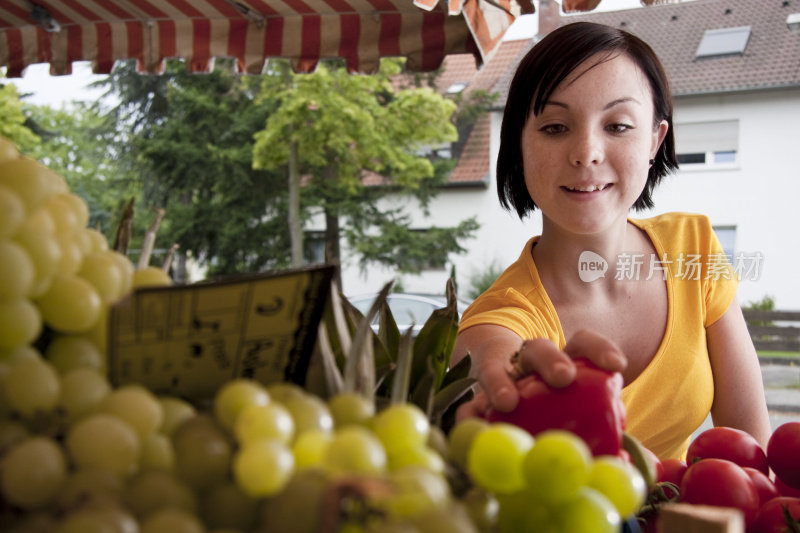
[686,426,769,476]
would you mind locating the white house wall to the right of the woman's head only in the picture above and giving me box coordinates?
[652,89,800,310]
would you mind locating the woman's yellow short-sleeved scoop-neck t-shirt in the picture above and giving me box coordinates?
[459,213,738,459]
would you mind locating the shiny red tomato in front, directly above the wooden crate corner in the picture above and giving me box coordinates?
[680,457,759,526]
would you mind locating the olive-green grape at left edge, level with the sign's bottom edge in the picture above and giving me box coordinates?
[3,357,61,417]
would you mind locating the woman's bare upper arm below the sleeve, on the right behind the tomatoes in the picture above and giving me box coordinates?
[706,300,772,448]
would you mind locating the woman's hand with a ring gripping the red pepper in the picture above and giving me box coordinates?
[456,326,627,420]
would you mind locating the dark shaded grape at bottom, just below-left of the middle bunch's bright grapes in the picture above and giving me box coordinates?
[200,481,259,531]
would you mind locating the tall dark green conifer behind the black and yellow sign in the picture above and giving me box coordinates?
[97,61,288,275]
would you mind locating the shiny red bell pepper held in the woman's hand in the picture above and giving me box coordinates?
[485,359,625,456]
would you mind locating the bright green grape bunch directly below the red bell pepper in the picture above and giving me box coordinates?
[448,419,647,533]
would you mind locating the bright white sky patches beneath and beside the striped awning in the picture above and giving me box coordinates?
[8,0,641,108]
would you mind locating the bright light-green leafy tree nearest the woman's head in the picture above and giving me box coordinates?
[253,60,477,290]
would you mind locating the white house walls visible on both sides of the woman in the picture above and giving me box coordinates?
[336,89,800,310]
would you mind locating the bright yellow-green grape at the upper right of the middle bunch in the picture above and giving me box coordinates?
[372,403,430,452]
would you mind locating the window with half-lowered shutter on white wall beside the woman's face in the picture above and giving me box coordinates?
[675,120,739,169]
